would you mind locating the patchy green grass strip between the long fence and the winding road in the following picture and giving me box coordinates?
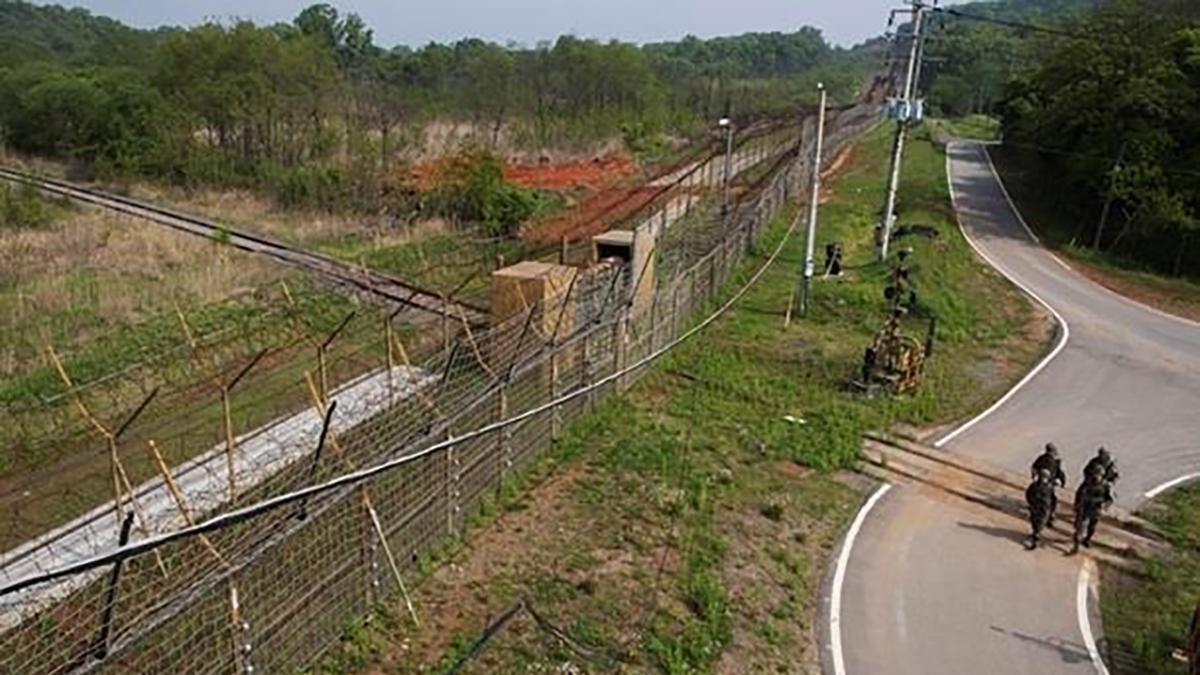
[318,121,1049,674]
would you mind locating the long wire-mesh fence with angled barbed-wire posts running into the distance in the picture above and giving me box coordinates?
[0,99,878,674]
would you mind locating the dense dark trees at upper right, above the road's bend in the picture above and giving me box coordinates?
[998,0,1200,275]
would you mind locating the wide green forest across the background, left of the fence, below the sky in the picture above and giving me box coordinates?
[0,0,877,210]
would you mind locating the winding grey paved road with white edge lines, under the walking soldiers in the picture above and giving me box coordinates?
[829,143,1200,675]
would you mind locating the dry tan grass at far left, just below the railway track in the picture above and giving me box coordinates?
[0,209,284,377]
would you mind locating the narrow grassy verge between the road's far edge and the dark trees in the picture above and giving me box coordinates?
[990,145,1200,321]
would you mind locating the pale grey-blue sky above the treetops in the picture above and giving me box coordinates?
[37,0,898,47]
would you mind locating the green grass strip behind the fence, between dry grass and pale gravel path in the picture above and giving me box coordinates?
[0,278,416,548]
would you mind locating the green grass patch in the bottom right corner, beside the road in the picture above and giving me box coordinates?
[1100,484,1200,675]
